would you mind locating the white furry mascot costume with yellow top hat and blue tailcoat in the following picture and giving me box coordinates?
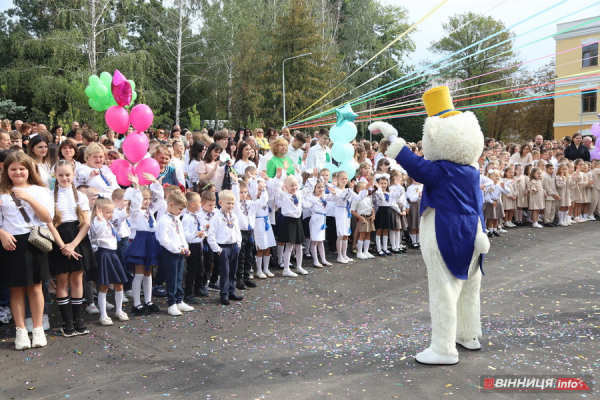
[369,86,490,365]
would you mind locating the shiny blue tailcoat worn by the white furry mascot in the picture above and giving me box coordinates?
[396,147,485,280]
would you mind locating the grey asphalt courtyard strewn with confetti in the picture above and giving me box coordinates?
[0,222,600,400]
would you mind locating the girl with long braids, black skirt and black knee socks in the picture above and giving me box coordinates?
[48,160,96,337]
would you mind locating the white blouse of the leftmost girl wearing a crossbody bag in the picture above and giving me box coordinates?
[0,185,54,235]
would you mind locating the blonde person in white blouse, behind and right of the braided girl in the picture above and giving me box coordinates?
[75,143,119,198]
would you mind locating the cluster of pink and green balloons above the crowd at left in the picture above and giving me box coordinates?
[85,70,160,186]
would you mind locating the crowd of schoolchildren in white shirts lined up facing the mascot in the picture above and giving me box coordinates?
[0,122,600,349]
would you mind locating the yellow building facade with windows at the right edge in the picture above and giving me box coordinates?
[554,15,600,139]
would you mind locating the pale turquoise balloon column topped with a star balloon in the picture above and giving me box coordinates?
[324,104,358,179]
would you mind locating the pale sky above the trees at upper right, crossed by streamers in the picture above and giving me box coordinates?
[380,0,600,69]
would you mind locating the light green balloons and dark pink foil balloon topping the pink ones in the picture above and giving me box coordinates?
[85,70,137,111]
